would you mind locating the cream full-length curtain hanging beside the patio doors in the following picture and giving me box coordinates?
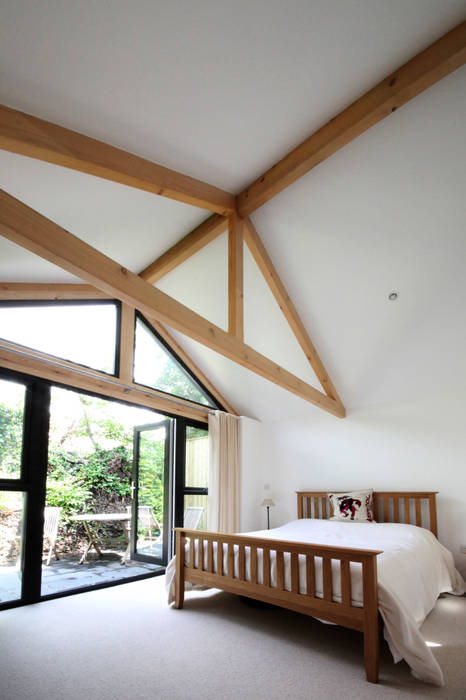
[207,411,239,532]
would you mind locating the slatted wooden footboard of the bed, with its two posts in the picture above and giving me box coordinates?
[175,528,381,683]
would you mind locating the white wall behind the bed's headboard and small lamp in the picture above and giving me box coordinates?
[243,397,466,574]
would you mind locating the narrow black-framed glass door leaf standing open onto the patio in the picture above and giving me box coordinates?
[130,418,173,566]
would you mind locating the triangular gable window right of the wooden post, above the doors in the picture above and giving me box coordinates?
[134,314,217,408]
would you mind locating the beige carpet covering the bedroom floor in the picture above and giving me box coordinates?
[0,577,466,700]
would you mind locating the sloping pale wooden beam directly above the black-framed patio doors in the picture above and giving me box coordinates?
[0,340,208,423]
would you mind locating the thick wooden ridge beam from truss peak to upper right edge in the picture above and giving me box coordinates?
[237,22,466,217]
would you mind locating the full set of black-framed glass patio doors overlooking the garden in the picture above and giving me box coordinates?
[0,368,208,609]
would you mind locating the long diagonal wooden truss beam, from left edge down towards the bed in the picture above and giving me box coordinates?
[0,190,344,417]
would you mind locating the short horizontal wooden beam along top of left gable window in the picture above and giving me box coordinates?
[0,282,112,301]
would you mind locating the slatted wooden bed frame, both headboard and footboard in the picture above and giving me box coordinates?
[175,489,437,683]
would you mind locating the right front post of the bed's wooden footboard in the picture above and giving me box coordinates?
[362,554,380,683]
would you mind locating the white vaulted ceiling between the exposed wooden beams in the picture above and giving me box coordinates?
[0,0,466,419]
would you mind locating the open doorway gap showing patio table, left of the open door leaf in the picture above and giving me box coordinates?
[41,387,164,596]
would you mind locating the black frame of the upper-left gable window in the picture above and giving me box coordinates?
[0,299,121,377]
